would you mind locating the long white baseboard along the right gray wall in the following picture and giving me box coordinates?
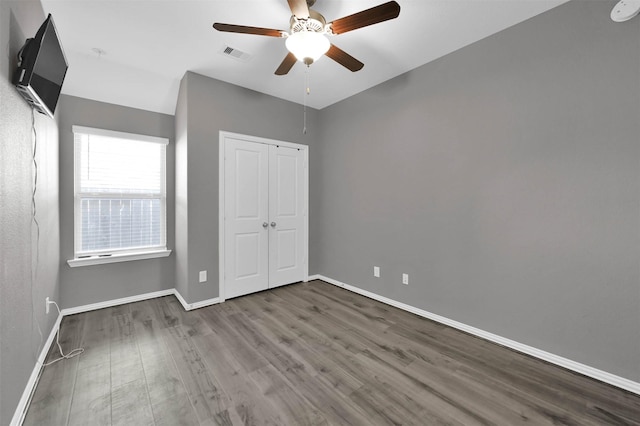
[309,275,640,395]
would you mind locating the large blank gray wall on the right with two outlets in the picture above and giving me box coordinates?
[312,0,640,381]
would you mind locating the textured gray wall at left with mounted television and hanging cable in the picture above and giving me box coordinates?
[0,0,60,425]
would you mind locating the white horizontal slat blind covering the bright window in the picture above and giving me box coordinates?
[73,126,169,258]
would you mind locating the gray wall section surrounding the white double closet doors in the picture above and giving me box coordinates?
[176,72,319,303]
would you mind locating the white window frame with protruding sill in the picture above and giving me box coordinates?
[67,125,171,267]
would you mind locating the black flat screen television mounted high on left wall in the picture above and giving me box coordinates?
[13,14,69,117]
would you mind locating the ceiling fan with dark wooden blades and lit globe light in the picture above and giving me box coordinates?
[213,0,400,75]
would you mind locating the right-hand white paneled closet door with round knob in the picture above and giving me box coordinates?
[269,145,306,288]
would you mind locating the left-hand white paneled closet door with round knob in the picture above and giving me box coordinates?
[225,138,271,298]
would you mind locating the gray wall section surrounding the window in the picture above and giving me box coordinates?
[58,96,175,307]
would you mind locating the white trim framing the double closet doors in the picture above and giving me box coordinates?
[218,130,309,302]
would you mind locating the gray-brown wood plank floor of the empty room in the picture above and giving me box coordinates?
[25,281,640,426]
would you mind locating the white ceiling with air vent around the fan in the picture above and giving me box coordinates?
[42,0,567,114]
